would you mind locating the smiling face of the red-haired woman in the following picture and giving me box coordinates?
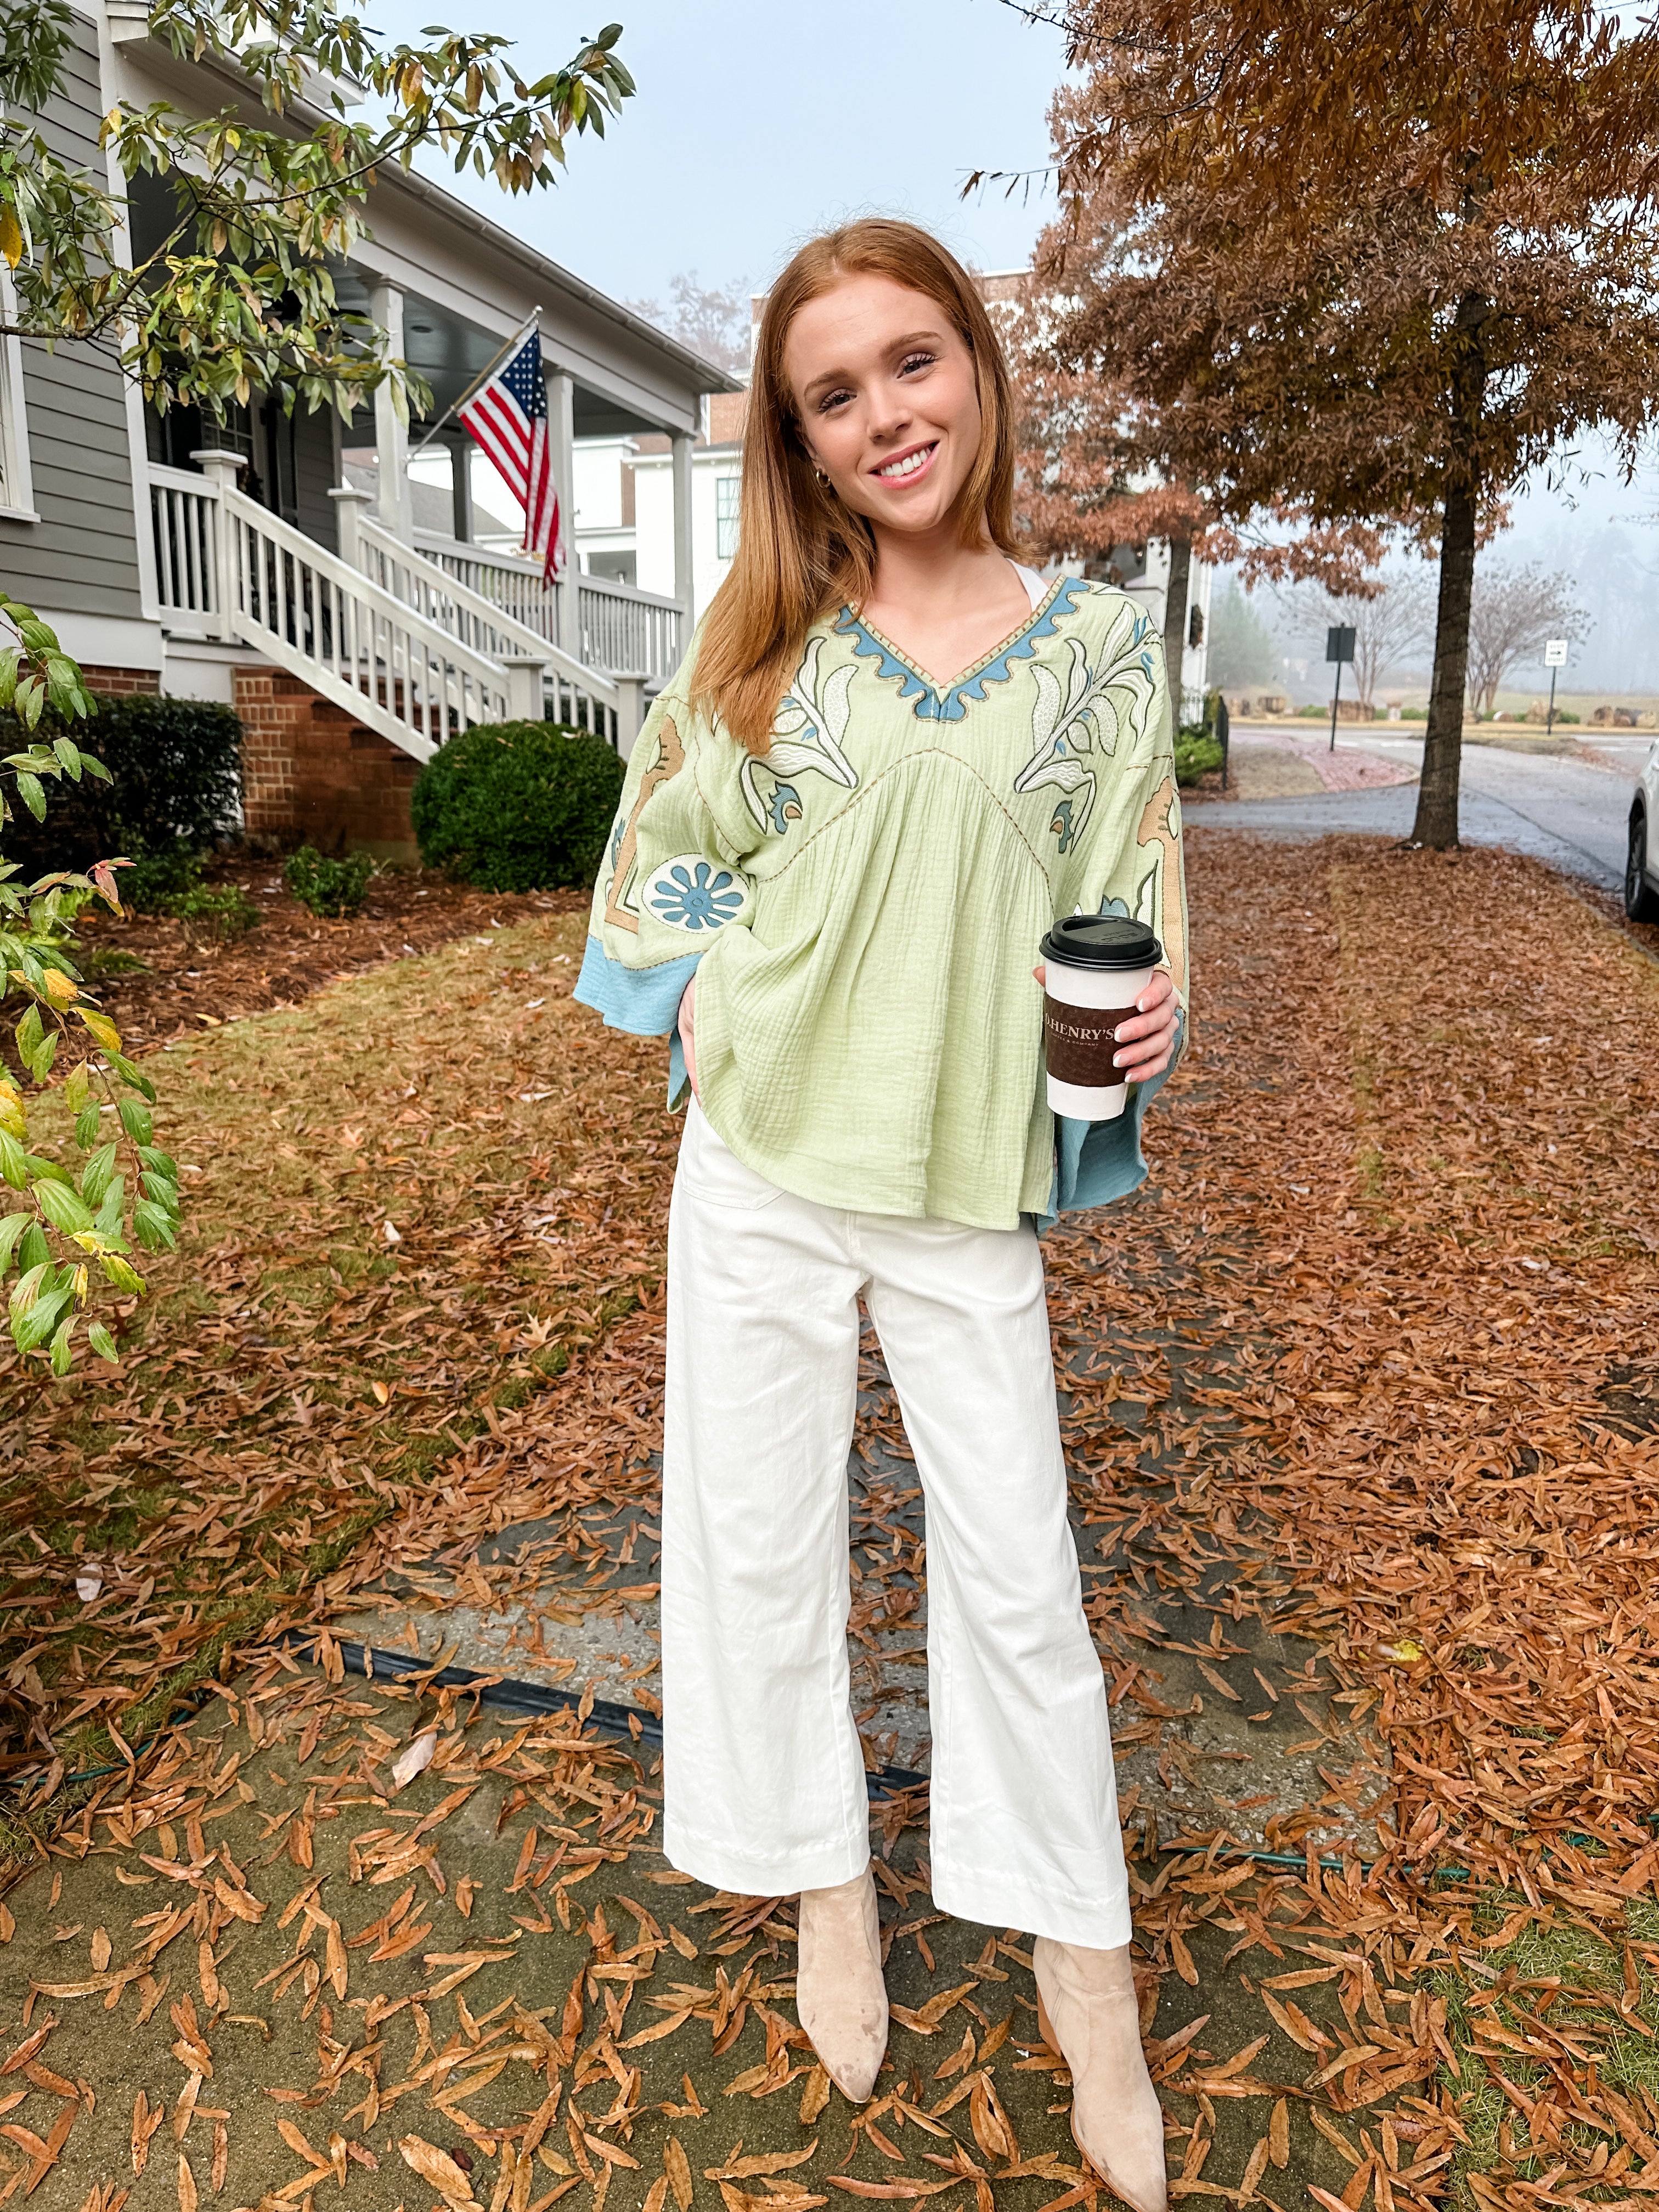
[783,276,982,535]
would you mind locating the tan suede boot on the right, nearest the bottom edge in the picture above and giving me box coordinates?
[1031,1936,1168,2212]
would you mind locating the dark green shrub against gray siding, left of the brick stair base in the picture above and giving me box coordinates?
[0,697,241,871]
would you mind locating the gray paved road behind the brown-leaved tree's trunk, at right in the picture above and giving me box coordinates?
[1188,730,1652,891]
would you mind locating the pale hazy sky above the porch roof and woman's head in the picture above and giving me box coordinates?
[369,0,1064,312]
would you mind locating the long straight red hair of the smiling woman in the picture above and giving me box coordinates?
[692,217,1013,754]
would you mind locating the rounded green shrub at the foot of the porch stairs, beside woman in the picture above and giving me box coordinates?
[411,721,624,891]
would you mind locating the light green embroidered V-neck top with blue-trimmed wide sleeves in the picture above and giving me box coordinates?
[577,577,1188,1228]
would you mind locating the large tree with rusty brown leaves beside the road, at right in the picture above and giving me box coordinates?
[1026,0,1659,847]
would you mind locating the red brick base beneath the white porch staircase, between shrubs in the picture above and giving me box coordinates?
[232,666,420,860]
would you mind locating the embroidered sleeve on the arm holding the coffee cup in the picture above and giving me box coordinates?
[1042,611,1188,1228]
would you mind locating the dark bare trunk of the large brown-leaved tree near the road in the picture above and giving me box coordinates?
[1411,292,1491,851]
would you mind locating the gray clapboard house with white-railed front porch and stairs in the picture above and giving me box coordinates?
[0,0,737,851]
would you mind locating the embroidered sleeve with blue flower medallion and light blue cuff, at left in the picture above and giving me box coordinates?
[575,692,754,1106]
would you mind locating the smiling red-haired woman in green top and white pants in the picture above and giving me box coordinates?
[577,221,1186,2212]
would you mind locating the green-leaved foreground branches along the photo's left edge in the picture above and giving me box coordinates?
[0,0,633,1376]
